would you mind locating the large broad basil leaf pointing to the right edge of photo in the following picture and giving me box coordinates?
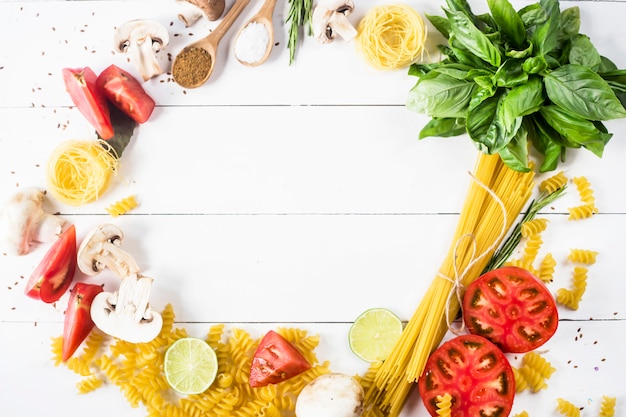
[544,64,626,120]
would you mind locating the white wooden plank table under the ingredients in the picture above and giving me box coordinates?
[0,0,626,417]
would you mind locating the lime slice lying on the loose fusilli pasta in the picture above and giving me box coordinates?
[163,337,217,394]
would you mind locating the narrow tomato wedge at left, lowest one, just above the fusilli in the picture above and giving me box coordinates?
[61,282,103,361]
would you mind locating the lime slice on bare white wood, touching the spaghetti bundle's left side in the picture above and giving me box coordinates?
[348,308,402,362]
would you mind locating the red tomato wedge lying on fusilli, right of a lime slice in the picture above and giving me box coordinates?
[250,330,311,388]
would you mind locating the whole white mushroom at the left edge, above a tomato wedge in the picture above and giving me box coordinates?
[0,188,66,255]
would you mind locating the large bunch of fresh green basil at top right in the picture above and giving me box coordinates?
[406,0,626,172]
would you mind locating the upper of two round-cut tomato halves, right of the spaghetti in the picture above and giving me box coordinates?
[463,266,559,353]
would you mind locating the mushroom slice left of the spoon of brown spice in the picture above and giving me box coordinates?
[114,19,170,81]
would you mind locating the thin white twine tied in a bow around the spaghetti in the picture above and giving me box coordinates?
[437,172,507,335]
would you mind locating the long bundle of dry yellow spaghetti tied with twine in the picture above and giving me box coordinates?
[365,153,534,416]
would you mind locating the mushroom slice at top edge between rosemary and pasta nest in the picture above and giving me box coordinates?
[311,0,357,43]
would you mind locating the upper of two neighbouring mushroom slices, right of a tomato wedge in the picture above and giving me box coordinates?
[77,223,139,279]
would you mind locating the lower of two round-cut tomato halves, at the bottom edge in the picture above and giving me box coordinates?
[418,334,515,417]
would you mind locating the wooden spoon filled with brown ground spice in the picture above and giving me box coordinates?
[172,0,250,88]
